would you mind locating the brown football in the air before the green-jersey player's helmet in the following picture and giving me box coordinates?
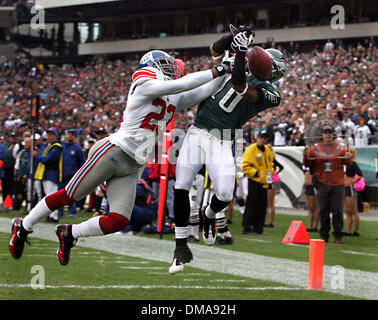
[248,46,273,81]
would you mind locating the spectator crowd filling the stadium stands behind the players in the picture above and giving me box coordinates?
[0,38,378,232]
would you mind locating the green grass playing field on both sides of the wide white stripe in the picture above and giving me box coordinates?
[0,208,378,300]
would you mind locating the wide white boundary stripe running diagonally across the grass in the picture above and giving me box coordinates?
[0,218,378,300]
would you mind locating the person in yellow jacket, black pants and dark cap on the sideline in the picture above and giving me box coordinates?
[241,130,274,234]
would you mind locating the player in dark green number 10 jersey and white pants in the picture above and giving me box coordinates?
[169,26,286,274]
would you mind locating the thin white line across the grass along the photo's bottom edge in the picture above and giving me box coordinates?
[0,284,307,291]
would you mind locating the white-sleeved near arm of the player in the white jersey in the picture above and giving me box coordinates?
[138,70,213,97]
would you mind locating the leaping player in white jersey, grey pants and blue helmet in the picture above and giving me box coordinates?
[9,50,231,265]
